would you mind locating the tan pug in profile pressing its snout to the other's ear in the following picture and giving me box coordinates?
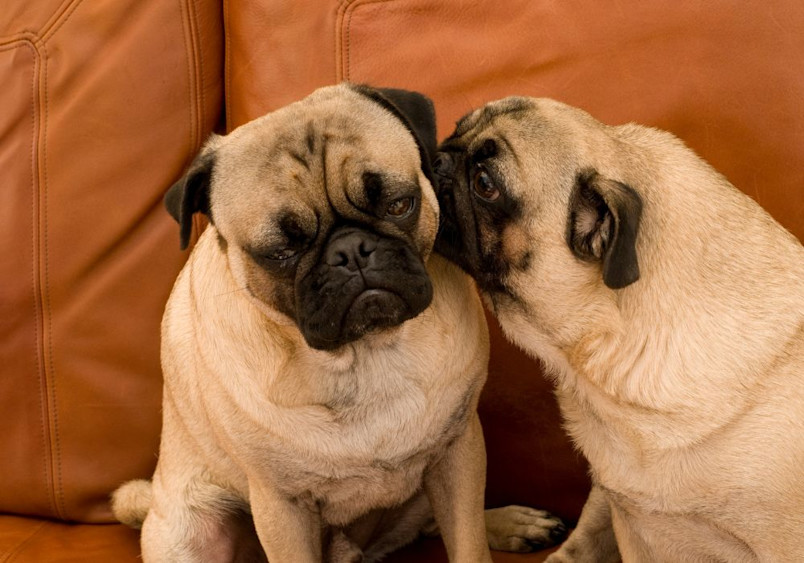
[435,98,804,562]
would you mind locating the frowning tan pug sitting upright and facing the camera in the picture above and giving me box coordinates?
[113,84,563,563]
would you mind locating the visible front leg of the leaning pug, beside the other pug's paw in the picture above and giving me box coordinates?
[545,485,621,563]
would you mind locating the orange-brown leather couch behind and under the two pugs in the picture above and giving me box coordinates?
[0,0,804,563]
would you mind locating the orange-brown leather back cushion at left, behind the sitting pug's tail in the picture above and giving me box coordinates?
[0,0,223,521]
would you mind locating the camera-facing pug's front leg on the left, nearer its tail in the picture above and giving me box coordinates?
[249,482,322,563]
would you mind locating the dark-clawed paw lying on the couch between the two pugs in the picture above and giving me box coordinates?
[486,505,567,553]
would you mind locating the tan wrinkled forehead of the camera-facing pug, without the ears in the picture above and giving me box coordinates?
[210,87,437,248]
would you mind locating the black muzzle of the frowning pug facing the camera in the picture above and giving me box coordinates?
[296,227,433,350]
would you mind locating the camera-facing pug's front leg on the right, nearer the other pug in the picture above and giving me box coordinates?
[424,413,491,563]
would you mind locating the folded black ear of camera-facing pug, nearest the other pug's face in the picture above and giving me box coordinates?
[351,84,438,182]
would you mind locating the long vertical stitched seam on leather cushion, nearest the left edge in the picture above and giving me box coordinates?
[40,0,87,519]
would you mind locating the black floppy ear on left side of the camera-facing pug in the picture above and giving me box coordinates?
[165,149,215,250]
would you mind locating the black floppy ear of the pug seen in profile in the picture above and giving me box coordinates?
[567,171,642,289]
